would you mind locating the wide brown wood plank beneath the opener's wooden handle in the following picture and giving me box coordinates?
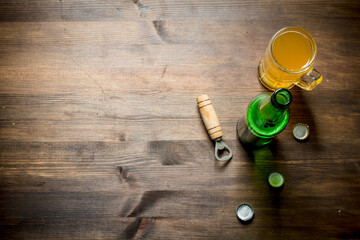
[0,89,360,143]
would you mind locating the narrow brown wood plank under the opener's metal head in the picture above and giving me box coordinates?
[0,135,358,174]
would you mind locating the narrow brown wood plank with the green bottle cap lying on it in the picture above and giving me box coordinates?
[1,159,359,192]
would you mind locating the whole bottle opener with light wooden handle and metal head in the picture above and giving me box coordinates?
[196,94,232,161]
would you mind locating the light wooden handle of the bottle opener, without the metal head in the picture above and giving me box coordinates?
[196,94,222,140]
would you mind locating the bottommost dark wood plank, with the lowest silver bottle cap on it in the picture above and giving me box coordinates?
[0,191,359,239]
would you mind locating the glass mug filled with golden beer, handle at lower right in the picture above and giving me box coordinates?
[258,27,322,91]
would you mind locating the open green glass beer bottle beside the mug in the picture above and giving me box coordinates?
[236,88,292,147]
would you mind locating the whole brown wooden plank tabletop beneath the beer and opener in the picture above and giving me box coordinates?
[0,0,360,239]
